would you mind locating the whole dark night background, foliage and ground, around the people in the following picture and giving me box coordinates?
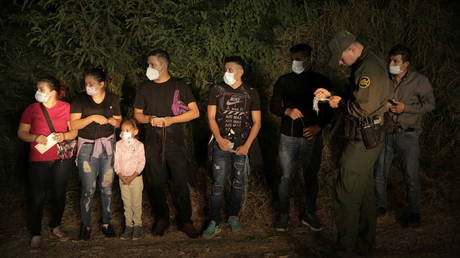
[0,0,460,257]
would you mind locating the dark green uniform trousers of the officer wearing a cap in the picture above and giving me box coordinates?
[335,141,383,252]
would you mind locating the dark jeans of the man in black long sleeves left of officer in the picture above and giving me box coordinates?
[278,134,322,215]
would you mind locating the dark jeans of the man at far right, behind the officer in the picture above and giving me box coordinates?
[375,132,422,213]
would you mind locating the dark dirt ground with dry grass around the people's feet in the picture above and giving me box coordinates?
[0,162,460,257]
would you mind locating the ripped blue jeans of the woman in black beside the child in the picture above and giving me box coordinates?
[78,143,114,227]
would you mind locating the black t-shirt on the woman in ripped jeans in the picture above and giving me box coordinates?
[70,91,121,140]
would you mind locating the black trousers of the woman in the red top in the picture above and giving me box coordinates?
[29,159,73,236]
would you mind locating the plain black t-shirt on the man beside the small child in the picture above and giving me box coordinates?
[134,78,196,144]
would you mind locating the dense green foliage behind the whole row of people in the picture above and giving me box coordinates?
[0,0,460,181]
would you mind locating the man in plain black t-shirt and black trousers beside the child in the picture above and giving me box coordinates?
[134,50,200,238]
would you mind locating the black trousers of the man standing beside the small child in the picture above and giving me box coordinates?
[144,135,192,224]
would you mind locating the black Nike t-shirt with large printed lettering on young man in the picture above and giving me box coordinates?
[208,84,260,148]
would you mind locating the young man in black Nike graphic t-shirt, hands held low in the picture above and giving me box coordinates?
[203,57,261,238]
